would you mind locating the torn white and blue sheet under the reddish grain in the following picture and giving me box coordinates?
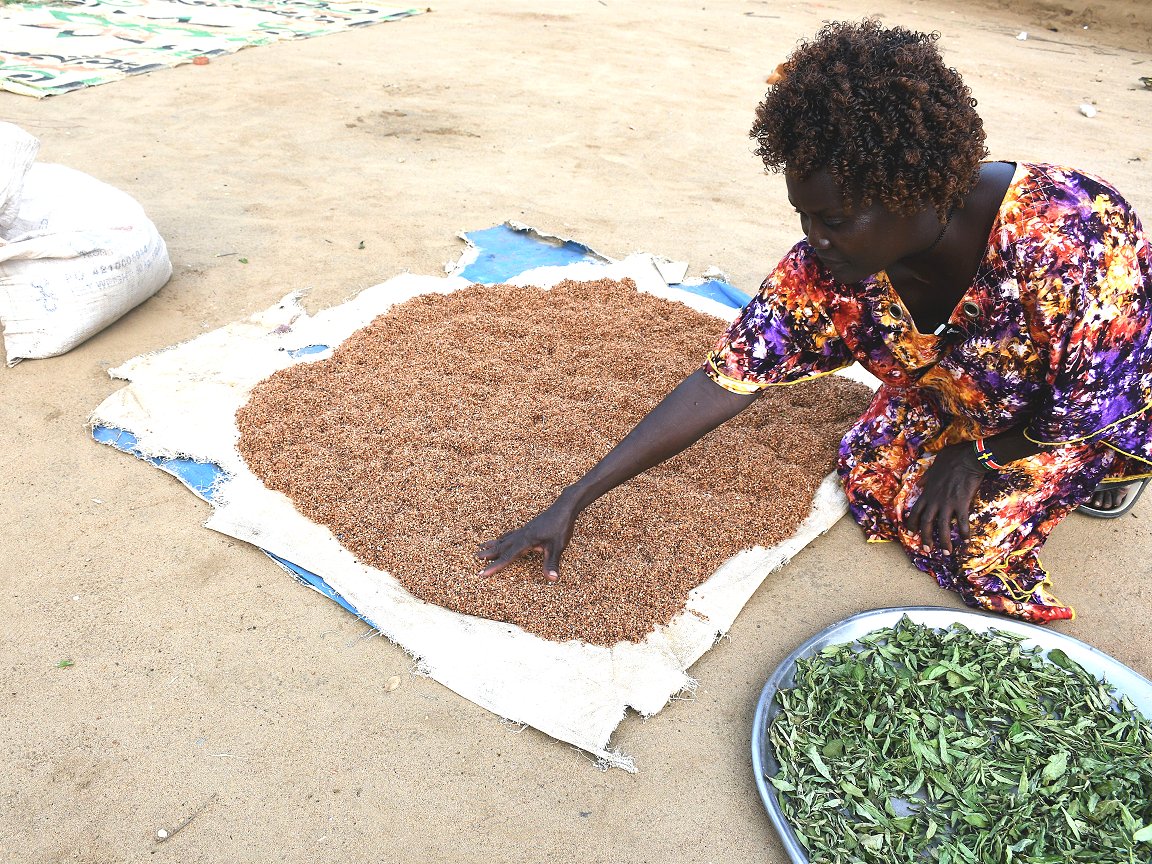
[92,228,875,770]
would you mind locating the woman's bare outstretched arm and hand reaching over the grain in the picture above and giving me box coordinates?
[477,370,756,579]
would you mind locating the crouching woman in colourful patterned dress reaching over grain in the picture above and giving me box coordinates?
[478,21,1152,623]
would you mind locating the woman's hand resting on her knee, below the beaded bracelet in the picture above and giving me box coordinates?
[904,442,987,553]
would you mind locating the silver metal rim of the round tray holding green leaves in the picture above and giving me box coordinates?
[752,606,1152,864]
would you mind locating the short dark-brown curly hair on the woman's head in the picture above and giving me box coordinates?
[751,18,987,219]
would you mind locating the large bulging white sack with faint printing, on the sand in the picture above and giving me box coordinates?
[0,162,172,366]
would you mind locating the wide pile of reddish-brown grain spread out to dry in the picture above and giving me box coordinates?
[237,280,867,645]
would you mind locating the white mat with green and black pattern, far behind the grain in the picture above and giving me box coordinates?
[0,0,424,97]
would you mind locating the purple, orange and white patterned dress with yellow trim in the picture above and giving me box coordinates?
[704,164,1152,623]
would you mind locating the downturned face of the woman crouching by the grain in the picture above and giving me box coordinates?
[785,168,941,283]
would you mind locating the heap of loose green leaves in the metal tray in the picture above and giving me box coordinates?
[768,617,1152,864]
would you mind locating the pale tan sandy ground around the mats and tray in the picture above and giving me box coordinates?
[0,0,1152,864]
